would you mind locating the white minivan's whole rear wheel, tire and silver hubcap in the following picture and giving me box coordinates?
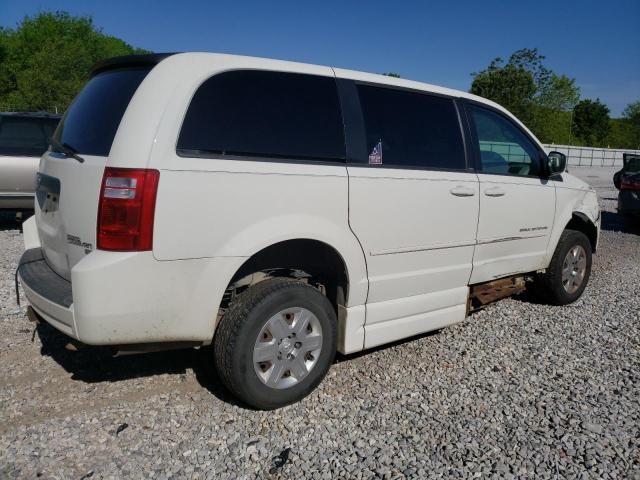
[214,278,337,410]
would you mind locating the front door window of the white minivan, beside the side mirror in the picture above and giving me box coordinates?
[468,104,540,177]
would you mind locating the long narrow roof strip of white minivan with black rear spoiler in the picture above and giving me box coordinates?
[91,52,539,142]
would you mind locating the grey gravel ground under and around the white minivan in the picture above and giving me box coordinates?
[0,177,640,479]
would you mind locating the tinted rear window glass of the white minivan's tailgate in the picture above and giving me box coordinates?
[55,68,150,157]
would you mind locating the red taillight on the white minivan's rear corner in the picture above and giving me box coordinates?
[97,167,160,252]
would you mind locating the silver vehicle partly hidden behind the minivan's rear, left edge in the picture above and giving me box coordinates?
[0,112,60,210]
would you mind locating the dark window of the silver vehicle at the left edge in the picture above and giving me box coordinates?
[0,115,58,157]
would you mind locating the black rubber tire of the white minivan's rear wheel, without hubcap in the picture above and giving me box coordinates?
[213,278,338,410]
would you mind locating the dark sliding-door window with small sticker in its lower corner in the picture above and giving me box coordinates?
[358,84,466,170]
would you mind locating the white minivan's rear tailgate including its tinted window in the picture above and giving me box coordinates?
[36,66,150,280]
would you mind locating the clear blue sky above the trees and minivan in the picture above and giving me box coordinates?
[0,0,640,116]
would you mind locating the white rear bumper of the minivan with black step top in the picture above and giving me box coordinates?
[18,247,244,346]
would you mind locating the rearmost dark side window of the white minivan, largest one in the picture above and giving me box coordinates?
[177,70,345,161]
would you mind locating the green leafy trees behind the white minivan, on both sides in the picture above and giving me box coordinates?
[0,12,640,149]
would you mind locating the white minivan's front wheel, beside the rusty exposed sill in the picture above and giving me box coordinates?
[536,230,591,305]
